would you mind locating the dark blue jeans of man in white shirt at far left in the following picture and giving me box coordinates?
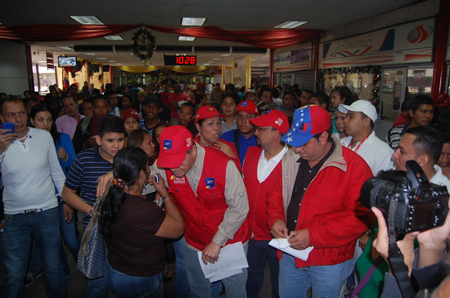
[1,207,67,297]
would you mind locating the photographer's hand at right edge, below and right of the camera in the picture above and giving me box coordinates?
[417,201,450,268]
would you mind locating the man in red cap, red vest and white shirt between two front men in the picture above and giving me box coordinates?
[243,110,289,298]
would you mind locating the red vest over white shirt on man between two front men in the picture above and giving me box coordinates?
[243,146,281,240]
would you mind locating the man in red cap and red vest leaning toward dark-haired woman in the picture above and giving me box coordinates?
[153,125,250,297]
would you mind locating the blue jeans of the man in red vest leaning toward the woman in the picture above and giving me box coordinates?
[185,245,248,298]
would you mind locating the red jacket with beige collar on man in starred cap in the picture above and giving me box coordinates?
[267,136,373,267]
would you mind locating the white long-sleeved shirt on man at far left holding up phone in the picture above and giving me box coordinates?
[0,128,66,214]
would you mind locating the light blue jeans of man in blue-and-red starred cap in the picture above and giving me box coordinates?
[278,254,354,298]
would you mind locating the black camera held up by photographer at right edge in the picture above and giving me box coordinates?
[360,160,449,234]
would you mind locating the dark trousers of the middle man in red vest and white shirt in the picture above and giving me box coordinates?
[246,239,280,298]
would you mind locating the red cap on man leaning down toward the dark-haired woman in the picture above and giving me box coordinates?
[157,125,194,169]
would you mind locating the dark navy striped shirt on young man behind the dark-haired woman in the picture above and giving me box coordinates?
[65,146,112,230]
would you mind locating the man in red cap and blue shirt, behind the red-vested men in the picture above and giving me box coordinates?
[220,100,259,165]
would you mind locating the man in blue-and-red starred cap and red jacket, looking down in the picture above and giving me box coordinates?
[267,105,373,297]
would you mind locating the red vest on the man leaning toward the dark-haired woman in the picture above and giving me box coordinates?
[166,147,250,250]
